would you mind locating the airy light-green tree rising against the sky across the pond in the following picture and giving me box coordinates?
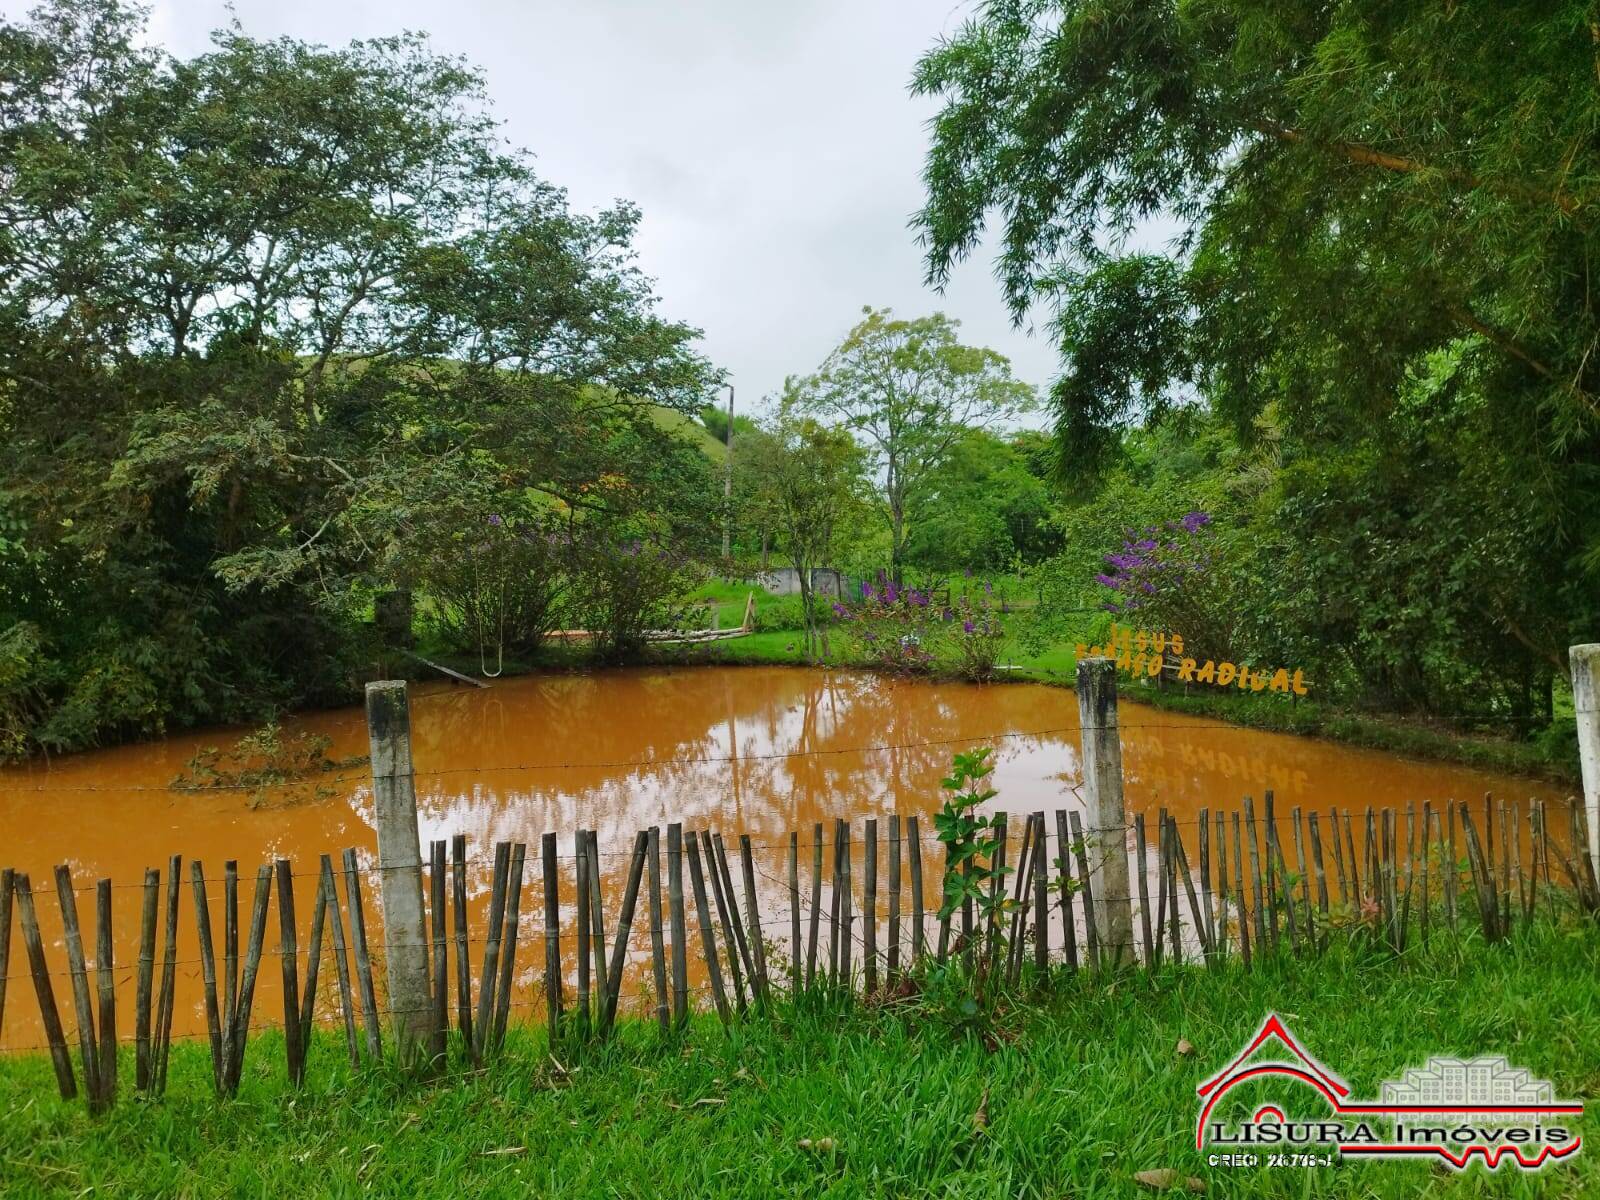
[792,307,1034,582]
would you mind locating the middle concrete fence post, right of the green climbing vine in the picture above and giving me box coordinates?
[1062,658,1133,962]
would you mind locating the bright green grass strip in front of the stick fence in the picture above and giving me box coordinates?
[0,925,1600,1200]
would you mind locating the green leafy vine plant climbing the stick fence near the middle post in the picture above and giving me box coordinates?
[933,746,1016,1018]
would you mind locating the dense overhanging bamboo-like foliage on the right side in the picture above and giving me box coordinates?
[915,0,1600,752]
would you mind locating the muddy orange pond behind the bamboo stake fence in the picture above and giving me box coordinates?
[0,667,1565,1050]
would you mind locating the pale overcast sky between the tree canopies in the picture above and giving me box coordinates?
[78,0,1075,411]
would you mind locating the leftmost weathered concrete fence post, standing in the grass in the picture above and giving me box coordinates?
[366,680,434,1062]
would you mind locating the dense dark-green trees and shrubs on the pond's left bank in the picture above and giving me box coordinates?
[0,0,717,755]
